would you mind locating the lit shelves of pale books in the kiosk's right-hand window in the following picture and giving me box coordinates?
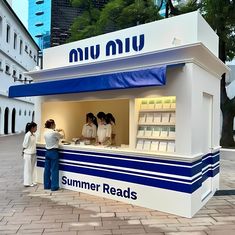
[136,97,176,152]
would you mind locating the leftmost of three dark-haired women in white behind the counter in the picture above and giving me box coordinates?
[82,113,98,141]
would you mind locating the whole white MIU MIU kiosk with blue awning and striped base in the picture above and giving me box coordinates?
[9,12,228,217]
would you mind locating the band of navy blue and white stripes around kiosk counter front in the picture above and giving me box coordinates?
[37,148,219,193]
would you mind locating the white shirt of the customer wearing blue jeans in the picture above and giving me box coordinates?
[44,129,63,149]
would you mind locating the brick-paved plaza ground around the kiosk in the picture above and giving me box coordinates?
[0,135,235,235]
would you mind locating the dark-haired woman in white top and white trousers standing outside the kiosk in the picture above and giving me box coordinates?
[23,122,37,187]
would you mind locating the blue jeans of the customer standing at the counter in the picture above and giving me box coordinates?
[44,149,59,191]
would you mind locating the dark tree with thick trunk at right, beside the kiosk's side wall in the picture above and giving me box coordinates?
[201,0,235,147]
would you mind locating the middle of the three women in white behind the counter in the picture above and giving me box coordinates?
[97,112,112,145]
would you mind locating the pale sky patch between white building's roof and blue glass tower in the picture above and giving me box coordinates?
[12,0,28,28]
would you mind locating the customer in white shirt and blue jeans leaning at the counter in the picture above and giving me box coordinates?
[44,119,64,191]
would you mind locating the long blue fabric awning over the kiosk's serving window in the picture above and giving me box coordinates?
[9,65,170,97]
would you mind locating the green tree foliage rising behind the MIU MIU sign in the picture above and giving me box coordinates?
[69,0,161,41]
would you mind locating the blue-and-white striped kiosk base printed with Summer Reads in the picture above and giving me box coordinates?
[37,147,220,217]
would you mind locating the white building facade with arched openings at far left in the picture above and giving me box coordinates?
[0,0,39,135]
